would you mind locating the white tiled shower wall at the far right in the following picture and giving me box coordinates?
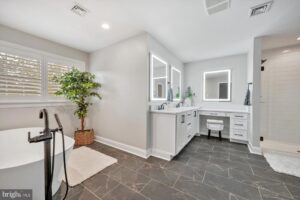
[261,45,300,145]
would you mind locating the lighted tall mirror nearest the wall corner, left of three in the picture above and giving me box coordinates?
[150,54,168,100]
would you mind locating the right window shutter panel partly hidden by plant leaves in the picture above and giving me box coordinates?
[47,62,72,95]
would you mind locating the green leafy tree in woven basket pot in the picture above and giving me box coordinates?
[53,68,101,145]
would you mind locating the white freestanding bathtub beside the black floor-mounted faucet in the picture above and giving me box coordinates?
[0,127,74,200]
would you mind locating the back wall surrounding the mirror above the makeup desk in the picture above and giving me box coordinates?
[184,54,247,108]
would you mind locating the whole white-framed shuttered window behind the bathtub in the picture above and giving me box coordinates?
[0,42,84,103]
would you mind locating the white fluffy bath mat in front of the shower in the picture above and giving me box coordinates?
[264,152,300,177]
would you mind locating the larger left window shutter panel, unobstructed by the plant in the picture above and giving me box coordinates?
[0,50,42,97]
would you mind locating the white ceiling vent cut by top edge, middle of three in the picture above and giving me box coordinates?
[204,0,230,15]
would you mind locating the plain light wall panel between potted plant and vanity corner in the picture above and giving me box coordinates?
[90,34,148,149]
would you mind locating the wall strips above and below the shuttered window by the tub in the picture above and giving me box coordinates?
[0,25,88,135]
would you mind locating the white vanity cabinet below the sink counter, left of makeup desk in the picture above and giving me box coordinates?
[151,108,199,160]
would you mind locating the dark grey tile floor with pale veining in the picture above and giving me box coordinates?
[55,137,300,200]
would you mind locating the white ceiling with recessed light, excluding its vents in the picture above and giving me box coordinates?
[0,0,300,62]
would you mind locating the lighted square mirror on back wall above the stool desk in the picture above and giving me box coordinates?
[203,69,231,101]
